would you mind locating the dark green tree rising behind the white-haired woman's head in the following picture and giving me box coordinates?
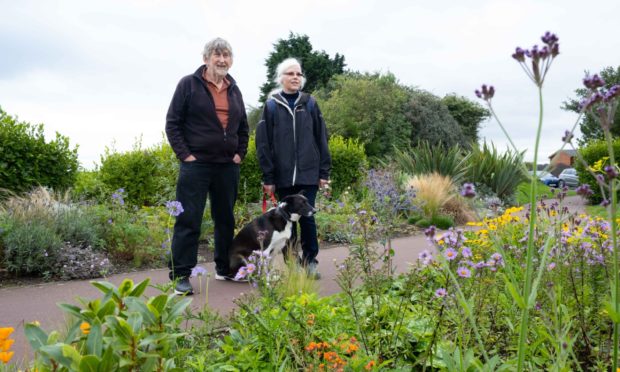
[259,32,346,104]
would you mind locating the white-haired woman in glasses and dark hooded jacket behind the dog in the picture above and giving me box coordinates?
[256,58,331,279]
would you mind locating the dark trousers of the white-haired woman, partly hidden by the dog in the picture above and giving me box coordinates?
[276,185,319,266]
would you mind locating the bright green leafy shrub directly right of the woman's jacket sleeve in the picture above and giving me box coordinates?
[329,135,368,196]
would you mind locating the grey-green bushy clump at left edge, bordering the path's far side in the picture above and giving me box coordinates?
[0,188,109,278]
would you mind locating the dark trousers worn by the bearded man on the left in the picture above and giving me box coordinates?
[168,161,239,279]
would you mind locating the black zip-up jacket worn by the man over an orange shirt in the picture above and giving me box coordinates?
[166,65,249,163]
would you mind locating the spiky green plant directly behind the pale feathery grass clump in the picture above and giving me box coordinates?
[394,141,468,184]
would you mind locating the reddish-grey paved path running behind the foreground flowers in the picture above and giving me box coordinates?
[0,234,430,363]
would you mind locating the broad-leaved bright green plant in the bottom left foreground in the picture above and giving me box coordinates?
[25,279,190,371]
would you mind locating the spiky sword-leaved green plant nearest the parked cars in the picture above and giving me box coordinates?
[467,142,526,204]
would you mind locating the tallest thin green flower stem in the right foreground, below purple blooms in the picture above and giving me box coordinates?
[517,86,543,371]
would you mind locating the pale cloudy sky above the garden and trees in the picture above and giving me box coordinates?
[0,0,620,168]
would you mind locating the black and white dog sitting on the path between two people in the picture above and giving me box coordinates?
[230,193,316,275]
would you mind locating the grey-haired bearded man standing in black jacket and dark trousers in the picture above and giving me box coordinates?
[166,38,249,294]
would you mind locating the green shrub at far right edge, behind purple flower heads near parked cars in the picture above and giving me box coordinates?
[575,139,620,204]
